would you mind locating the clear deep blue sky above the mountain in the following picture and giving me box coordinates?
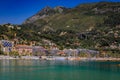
[0,0,120,24]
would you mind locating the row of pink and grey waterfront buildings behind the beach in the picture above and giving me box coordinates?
[0,40,100,59]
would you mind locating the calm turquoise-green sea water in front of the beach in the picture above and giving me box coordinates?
[0,60,120,80]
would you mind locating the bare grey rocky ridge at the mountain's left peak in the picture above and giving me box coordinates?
[23,6,67,24]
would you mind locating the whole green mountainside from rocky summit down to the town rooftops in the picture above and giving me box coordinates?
[0,2,120,52]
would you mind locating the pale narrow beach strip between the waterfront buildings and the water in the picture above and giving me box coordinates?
[0,55,120,61]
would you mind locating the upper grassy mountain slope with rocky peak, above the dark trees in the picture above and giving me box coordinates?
[24,2,120,31]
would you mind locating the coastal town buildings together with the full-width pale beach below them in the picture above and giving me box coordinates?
[0,34,120,60]
